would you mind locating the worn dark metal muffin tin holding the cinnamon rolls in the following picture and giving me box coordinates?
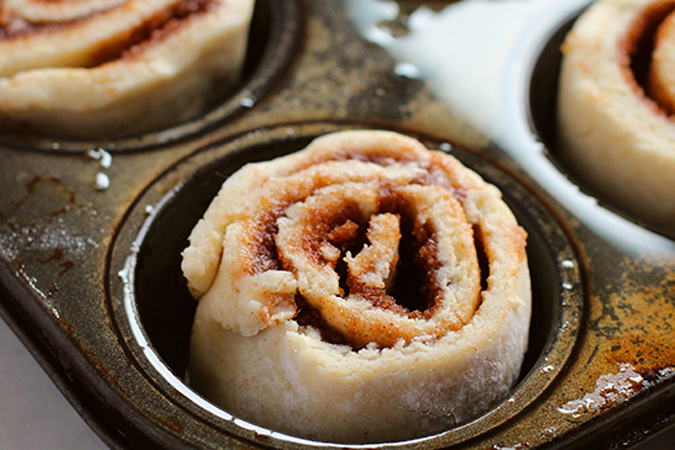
[0,0,675,449]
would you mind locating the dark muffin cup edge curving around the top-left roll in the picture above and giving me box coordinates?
[0,0,304,153]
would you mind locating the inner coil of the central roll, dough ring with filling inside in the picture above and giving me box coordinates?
[276,182,480,348]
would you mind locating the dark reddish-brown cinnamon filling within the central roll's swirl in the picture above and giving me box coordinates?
[246,179,489,350]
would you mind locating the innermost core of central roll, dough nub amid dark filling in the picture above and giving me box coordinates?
[282,191,440,319]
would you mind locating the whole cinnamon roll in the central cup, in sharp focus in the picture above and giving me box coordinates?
[182,131,531,443]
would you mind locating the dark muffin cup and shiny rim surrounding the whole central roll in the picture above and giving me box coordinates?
[107,123,584,449]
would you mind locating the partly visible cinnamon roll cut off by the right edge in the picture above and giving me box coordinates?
[558,0,675,233]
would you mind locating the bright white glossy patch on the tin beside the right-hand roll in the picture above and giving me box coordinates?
[347,0,675,256]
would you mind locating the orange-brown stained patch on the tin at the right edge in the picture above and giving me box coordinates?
[579,258,675,386]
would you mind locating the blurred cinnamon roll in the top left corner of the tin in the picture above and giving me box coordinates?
[0,0,253,138]
